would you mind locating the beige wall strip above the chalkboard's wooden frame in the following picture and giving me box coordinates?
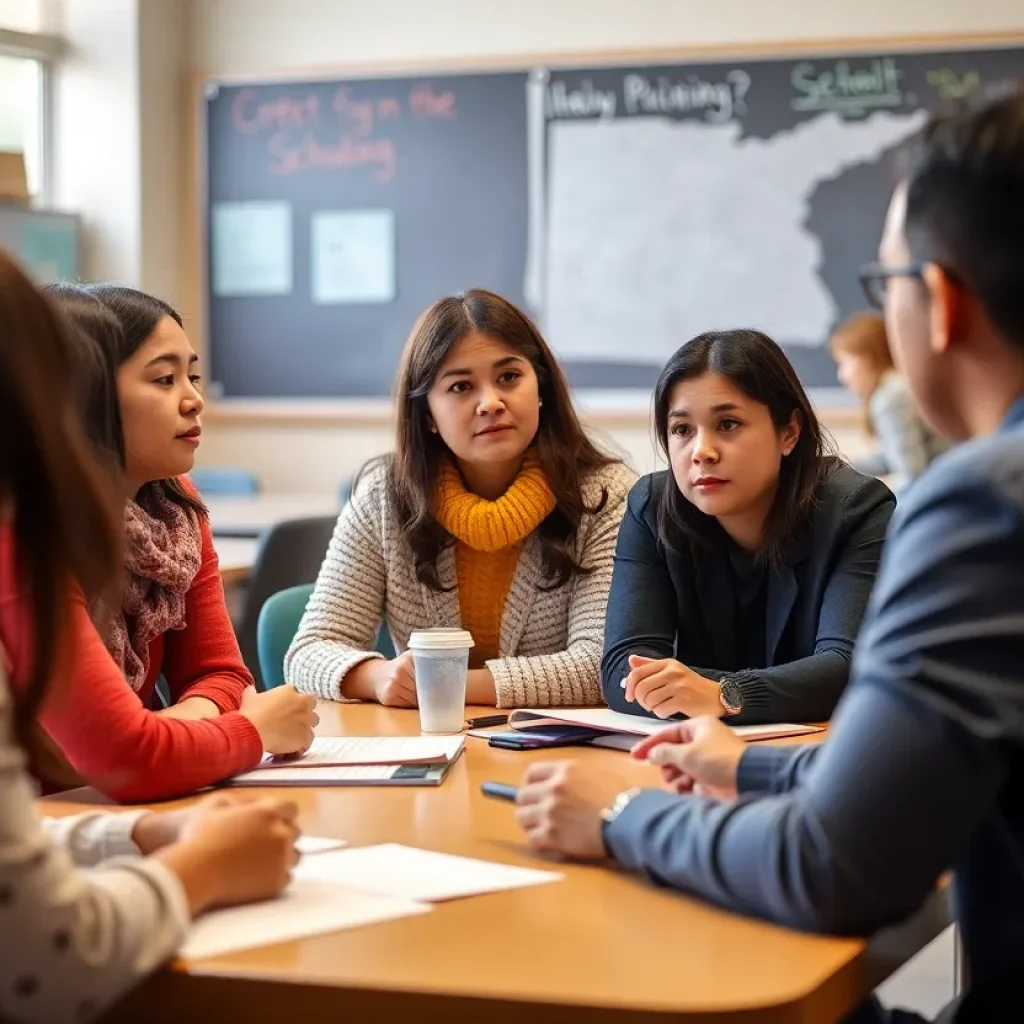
[191,0,1024,74]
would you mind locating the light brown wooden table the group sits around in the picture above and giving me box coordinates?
[42,703,947,1024]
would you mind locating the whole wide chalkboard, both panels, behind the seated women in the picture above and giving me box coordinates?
[207,46,1024,397]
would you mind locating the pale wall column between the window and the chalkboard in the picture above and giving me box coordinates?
[52,0,190,302]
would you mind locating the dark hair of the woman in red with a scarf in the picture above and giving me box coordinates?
[66,284,207,518]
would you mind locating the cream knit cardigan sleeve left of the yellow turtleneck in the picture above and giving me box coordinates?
[285,472,387,700]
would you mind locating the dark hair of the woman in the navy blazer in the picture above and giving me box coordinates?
[654,330,838,564]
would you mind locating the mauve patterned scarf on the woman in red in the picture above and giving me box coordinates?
[106,483,203,691]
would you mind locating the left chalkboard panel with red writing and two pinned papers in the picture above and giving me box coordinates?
[206,74,527,396]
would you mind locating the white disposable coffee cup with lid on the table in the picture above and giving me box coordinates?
[409,627,473,733]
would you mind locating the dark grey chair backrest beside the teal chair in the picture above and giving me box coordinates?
[236,516,335,688]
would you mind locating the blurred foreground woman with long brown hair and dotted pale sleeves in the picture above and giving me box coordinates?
[0,252,297,1024]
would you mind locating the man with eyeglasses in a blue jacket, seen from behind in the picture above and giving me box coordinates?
[517,92,1024,1024]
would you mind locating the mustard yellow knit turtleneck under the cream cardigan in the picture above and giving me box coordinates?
[437,459,555,668]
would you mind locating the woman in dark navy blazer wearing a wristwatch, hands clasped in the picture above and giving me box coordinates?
[601,331,896,724]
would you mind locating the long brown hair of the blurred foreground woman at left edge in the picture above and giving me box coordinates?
[0,251,122,745]
